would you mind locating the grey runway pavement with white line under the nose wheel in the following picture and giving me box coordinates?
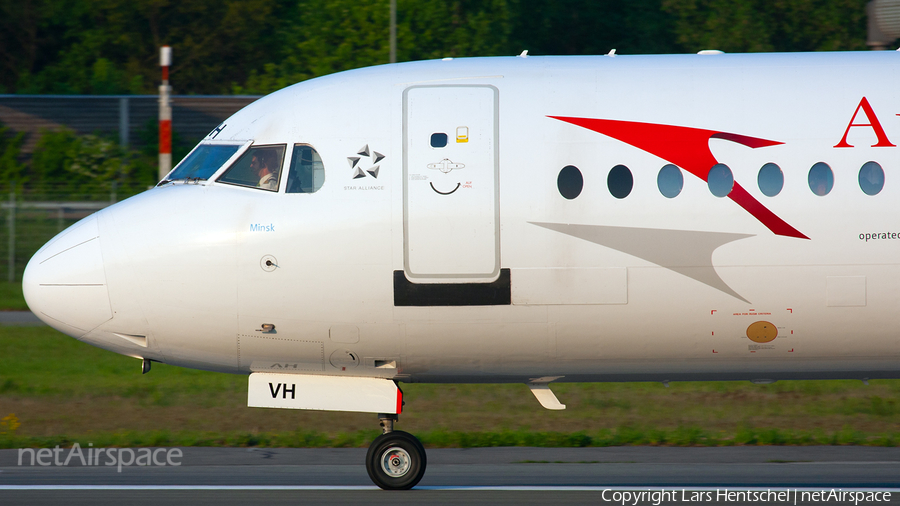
[0,446,900,505]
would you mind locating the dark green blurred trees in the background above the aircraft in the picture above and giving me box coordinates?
[0,0,880,94]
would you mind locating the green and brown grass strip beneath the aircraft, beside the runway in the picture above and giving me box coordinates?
[0,327,900,448]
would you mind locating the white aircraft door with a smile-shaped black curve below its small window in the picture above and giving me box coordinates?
[403,85,500,283]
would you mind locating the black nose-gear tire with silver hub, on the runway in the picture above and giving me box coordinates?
[366,430,426,490]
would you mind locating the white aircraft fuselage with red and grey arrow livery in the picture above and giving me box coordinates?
[24,52,900,382]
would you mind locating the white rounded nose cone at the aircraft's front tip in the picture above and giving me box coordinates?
[22,214,112,337]
